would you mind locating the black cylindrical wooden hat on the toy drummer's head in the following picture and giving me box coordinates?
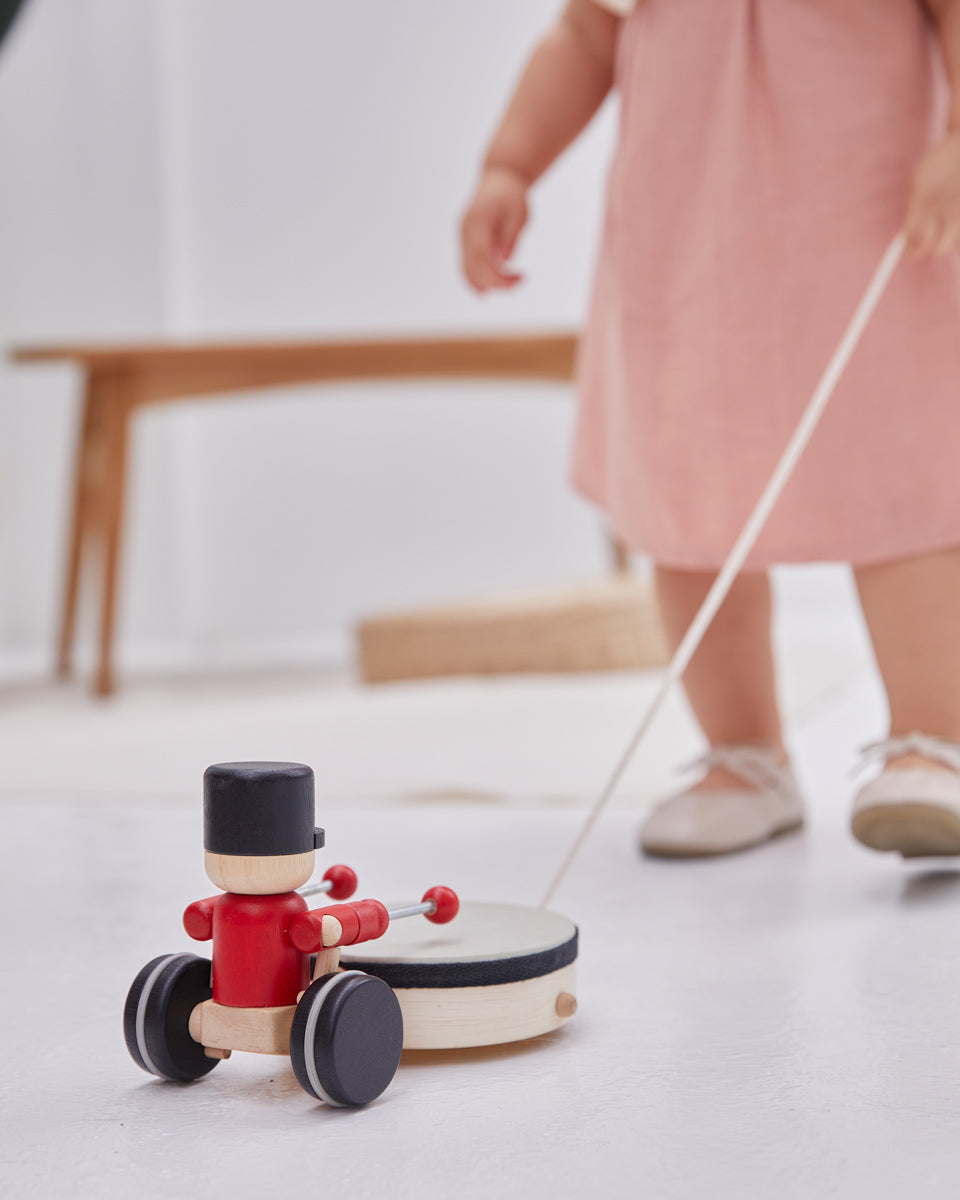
[203,762,323,857]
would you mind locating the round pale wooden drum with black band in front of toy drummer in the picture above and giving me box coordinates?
[342,902,577,1050]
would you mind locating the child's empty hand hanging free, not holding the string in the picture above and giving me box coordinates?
[460,167,527,292]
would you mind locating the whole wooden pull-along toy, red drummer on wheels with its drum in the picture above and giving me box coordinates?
[124,762,577,1105]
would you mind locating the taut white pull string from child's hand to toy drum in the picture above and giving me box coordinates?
[540,234,906,908]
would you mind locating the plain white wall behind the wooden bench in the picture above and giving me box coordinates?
[0,0,854,670]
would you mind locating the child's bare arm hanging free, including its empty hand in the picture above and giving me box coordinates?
[461,0,620,292]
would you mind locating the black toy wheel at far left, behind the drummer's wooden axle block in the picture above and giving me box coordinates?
[124,954,220,1084]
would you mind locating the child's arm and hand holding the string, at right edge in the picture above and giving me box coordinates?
[906,0,960,256]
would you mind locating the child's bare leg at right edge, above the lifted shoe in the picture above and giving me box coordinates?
[854,550,960,767]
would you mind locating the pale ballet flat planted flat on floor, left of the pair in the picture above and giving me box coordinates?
[640,745,803,858]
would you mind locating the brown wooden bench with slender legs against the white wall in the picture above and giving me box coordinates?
[12,334,600,696]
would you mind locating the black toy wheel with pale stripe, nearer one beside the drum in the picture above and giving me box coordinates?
[290,971,403,1106]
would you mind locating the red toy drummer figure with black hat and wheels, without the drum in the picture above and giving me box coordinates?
[124,762,458,1105]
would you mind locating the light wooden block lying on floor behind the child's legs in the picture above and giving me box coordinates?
[358,575,668,683]
